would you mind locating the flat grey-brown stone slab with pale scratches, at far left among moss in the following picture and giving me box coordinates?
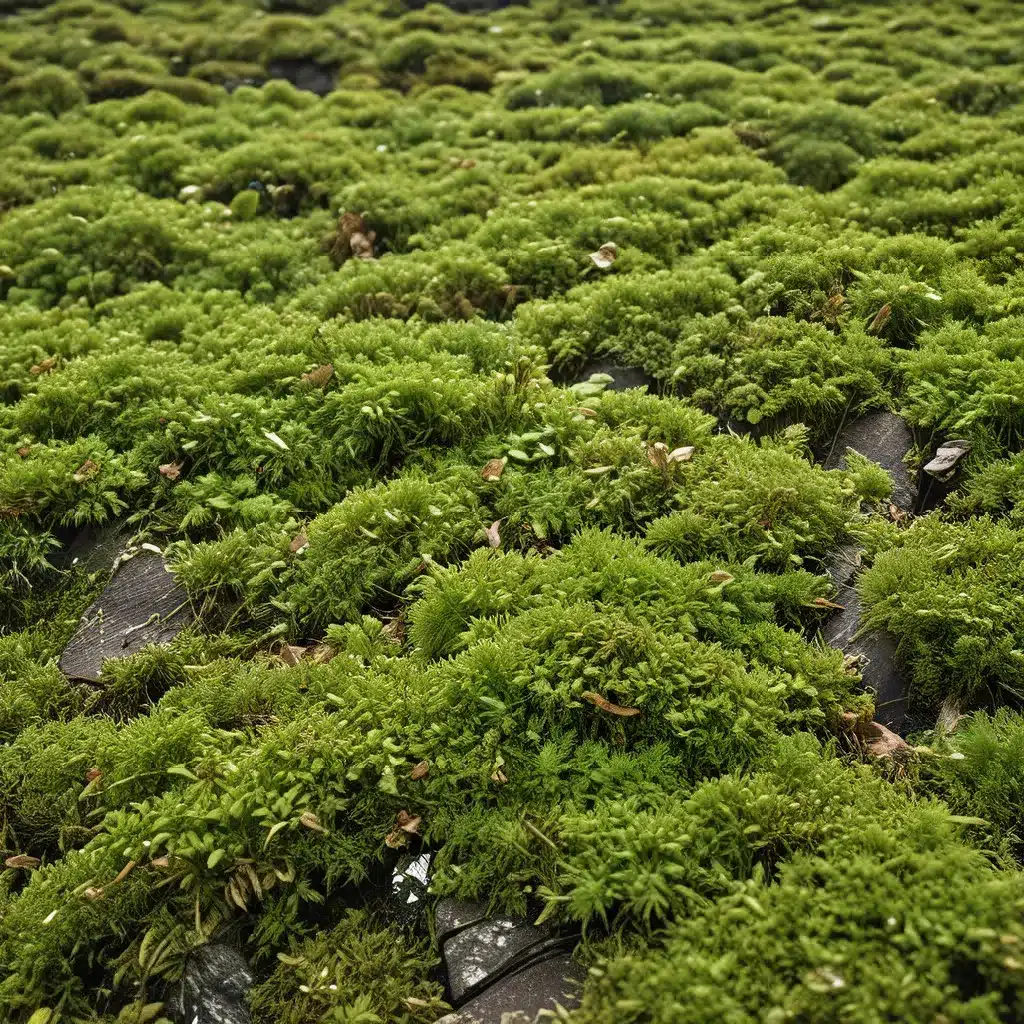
[59,549,194,683]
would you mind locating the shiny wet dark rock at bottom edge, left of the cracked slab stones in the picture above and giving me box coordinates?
[168,943,253,1024]
